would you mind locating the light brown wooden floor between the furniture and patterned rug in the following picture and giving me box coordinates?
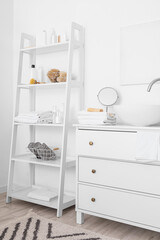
[0,193,160,240]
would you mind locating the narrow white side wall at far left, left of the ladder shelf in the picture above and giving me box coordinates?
[0,0,13,192]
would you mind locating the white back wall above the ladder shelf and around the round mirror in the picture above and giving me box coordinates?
[14,0,160,193]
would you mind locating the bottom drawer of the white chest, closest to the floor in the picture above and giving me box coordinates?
[77,184,160,228]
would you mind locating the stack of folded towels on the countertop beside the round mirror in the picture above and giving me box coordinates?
[78,111,116,125]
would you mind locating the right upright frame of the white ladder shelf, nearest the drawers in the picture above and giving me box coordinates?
[57,22,84,217]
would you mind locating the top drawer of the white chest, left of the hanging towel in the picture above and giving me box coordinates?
[77,130,136,160]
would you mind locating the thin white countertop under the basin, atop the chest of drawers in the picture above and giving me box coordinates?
[74,124,160,132]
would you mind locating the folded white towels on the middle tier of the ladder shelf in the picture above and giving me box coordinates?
[15,111,53,124]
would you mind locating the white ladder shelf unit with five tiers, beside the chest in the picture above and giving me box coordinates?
[6,22,84,217]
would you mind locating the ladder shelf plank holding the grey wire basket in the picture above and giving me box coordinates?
[11,154,76,168]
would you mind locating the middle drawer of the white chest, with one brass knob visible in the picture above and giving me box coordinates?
[78,157,160,195]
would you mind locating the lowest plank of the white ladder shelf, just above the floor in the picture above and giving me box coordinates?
[10,187,75,209]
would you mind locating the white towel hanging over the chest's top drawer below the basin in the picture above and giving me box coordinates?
[136,131,160,162]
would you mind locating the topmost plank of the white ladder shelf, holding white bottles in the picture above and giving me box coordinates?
[20,41,80,55]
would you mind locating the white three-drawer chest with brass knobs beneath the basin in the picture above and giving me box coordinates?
[76,125,160,232]
